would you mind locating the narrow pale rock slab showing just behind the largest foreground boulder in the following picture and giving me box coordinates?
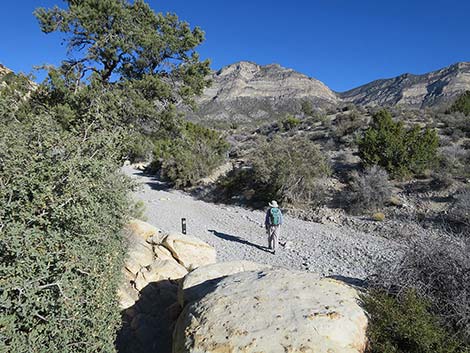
[178,261,271,307]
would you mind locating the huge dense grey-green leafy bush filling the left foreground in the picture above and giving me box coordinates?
[0,113,129,352]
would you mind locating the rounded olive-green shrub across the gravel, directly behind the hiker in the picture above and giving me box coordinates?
[231,137,330,206]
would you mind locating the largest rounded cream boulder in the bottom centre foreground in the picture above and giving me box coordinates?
[173,270,367,353]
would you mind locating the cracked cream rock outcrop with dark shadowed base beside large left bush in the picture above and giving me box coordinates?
[116,220,215,353]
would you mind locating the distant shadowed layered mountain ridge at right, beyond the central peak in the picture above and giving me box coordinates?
[339,62,470,108]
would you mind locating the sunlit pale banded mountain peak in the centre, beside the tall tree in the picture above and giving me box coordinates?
[186,61,339,121]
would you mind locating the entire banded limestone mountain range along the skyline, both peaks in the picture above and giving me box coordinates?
[187,61,470,123]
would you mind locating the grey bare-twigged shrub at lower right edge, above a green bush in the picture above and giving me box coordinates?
[371,235,470,345]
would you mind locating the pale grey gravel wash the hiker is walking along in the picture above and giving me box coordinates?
[123,166,401,279]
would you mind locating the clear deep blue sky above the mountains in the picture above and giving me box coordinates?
[0,0,470,91]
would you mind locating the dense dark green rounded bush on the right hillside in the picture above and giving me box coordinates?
[358,110,439,177]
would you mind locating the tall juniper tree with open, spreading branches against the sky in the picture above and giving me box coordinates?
[35,0,209,130]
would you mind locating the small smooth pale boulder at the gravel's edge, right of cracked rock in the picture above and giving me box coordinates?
[162,233,216,270]
